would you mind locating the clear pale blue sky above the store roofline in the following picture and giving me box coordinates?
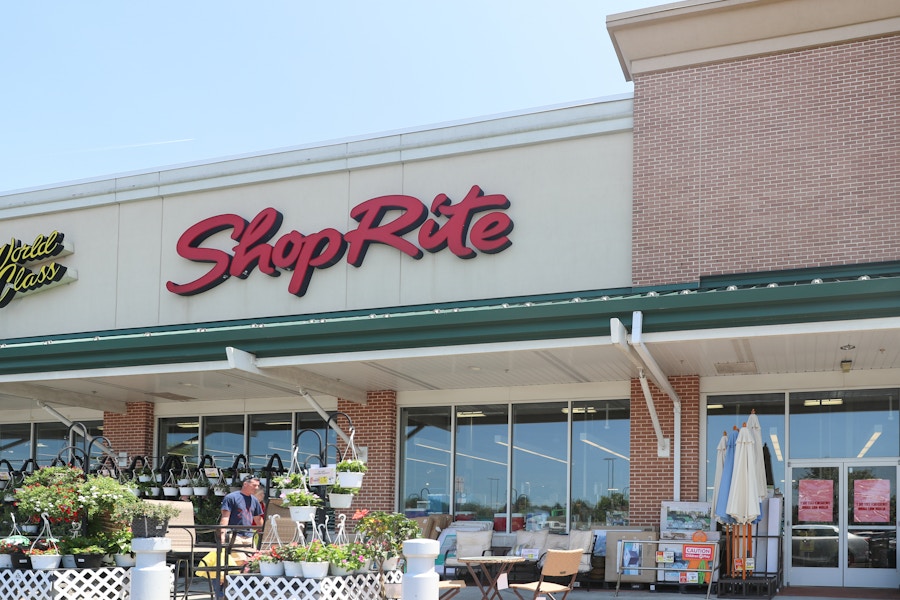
[0,0,666,192]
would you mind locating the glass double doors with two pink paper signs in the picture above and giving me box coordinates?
[785,460,900,588]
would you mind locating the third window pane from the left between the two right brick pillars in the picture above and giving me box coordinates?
[510,402,569,531]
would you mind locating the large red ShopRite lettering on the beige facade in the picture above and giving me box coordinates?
[166,185,513,296]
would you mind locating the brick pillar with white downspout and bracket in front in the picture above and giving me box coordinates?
[629,376,700,526]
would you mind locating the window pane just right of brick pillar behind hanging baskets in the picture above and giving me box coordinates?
[400,407,451,516]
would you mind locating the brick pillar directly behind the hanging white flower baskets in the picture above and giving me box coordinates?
[338,390,397,513]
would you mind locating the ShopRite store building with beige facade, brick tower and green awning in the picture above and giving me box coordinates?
[0,0,900,587]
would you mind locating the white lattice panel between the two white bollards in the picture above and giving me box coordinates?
[225,571,403,600]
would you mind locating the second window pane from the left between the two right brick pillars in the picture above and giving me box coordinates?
[453,404,510,521]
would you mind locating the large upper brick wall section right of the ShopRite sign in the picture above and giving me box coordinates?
[632,36,900,285]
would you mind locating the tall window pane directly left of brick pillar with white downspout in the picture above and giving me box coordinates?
[570,400,631,529]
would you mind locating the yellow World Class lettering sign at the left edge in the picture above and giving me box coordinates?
[0,231,76,308]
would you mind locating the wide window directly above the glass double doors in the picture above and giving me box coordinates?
[790,389,900,458]
